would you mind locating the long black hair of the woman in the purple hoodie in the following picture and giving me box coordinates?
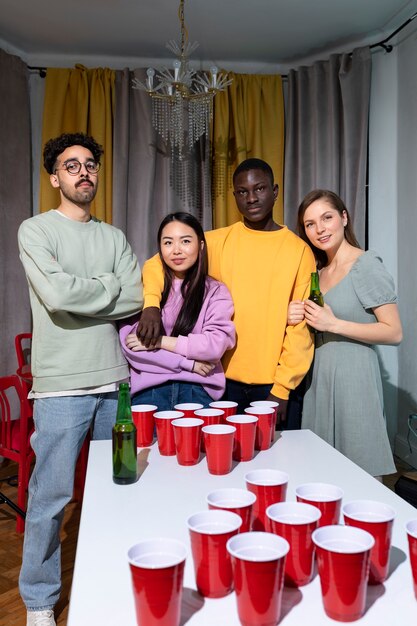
[158,212,208,337]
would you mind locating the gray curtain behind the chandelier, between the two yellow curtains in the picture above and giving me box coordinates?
[112,70,212,265]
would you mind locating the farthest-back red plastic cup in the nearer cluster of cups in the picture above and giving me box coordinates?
[245,469,289,530]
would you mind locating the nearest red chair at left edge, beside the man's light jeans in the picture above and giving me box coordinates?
[0,374,34,533]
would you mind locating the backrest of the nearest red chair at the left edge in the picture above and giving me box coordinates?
[0,374,32,450]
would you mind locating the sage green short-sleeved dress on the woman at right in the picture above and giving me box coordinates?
[302,251,397,476]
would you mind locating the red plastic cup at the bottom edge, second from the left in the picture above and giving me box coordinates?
[227,532,289,626]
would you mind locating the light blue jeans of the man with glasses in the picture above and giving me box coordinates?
[19,392,117,611]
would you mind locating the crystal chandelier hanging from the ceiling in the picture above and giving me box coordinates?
[133,0,232,161]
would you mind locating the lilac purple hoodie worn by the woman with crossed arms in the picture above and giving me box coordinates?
[119,276,236,400]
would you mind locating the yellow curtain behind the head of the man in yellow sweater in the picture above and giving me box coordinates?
[213,72,284,228]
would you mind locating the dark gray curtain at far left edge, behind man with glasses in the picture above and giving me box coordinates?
[0,50,32,376]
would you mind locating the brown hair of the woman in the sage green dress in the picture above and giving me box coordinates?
[297,189,360,269]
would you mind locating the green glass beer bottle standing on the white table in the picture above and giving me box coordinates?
[113,383,137,485]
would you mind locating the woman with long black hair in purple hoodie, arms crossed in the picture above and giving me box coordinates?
[120,212,235,411]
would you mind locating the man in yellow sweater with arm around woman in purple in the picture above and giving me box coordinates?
[138,159,315,425]
